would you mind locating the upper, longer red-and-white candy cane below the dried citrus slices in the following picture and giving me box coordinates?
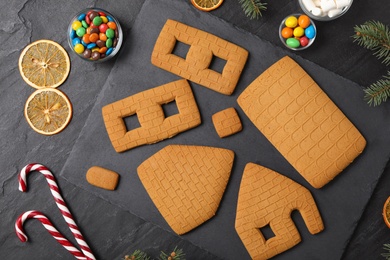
[19,163,96,260]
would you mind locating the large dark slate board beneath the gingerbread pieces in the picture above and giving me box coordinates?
[60,0,390,259]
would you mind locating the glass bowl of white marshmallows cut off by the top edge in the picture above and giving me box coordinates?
[298,0,353,21]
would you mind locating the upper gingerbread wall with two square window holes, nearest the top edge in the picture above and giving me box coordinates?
[151,20,248,95]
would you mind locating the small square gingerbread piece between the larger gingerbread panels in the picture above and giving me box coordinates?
[212,107,242,138]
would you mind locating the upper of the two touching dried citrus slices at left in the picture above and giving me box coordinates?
[19,40,70,89]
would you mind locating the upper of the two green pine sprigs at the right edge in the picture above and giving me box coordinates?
[353,21,390,65]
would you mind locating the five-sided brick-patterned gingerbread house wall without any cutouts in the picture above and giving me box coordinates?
[137,145,234,235]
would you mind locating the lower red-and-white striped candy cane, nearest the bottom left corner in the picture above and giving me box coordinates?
[15,210,87,260]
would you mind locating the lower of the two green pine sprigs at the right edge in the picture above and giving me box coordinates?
[364,71,390,106]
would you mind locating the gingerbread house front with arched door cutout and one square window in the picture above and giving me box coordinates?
[235,163,324,260]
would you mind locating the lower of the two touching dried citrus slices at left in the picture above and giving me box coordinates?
[24,88,72,135]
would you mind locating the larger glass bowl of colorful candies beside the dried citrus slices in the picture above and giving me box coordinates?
[68,8,123,62]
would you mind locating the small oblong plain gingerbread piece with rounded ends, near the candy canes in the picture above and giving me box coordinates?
[86,166,119,190]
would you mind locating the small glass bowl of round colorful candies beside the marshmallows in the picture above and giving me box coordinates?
[279,14,317,51]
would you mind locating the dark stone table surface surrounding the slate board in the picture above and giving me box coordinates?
[0,0,390,259]
